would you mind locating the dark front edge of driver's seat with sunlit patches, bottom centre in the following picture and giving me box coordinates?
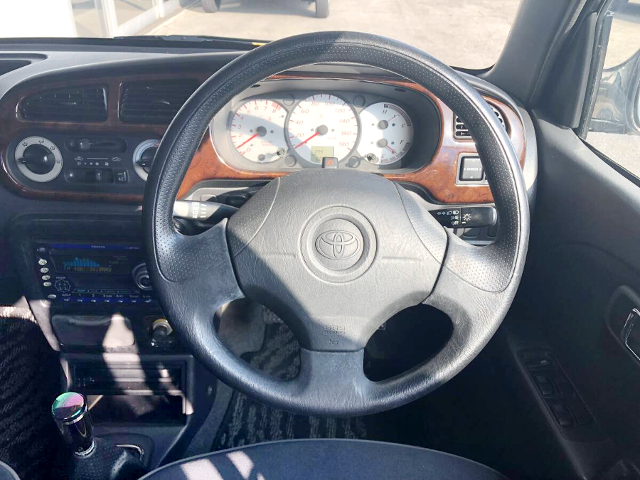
[143,439,505,480]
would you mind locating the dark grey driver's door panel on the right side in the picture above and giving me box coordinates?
[520,117,640,478]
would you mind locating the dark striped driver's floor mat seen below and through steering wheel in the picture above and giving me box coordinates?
[212,316,423,451]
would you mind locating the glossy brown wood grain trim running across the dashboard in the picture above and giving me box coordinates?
[0,72,526,204]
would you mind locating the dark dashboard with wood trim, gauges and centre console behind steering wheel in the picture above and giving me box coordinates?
[0,47,537,462]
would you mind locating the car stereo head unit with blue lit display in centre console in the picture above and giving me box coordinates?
[34,242,154,304]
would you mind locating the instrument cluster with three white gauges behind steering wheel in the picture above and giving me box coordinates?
[210,80,440,172]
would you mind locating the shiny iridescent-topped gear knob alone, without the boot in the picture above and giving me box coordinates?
[51,392,96,455]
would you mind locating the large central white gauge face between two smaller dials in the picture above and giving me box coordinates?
[288,93,358,163]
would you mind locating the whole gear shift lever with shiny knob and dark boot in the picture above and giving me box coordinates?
[51,392,146,480]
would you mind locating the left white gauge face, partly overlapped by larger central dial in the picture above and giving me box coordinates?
[229,99,287,163]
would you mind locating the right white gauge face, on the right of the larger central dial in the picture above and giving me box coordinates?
[358,102,413,165]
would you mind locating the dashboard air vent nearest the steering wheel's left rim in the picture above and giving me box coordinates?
[120,79,199,124]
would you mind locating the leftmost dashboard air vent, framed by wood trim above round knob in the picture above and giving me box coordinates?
[20,85,107,122]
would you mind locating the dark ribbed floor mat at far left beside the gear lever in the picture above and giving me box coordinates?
[0,316,64,480]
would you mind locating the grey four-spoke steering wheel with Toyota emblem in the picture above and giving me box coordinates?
[143,32,529,416]
